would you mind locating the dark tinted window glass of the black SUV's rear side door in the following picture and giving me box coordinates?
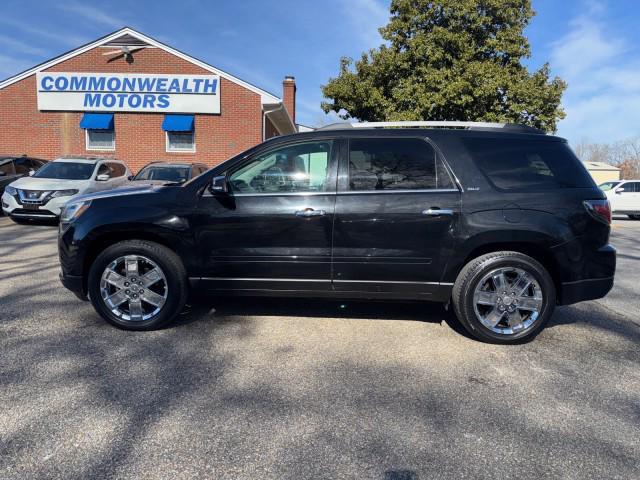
[349,138,454,191]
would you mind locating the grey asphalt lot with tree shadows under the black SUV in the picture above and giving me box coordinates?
[0,218,640,480]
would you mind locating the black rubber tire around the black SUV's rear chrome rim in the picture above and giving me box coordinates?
[452,251,556,344]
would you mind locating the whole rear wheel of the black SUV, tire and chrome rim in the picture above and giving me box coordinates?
[453,252,556,344]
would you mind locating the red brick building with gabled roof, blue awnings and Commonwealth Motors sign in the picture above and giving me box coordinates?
[0,28,296,172]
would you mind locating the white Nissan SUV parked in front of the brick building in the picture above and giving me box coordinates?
[2,157,131,221]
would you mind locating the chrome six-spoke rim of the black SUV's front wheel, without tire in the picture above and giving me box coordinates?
[100,255,169,322]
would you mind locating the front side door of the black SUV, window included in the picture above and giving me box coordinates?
[196,137,337,291]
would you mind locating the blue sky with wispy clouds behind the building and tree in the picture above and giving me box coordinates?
[0,0,640,144]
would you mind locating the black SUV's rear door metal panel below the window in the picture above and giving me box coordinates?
[333,191,460,293]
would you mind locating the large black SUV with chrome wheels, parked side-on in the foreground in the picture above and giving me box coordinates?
[59,122,616,343]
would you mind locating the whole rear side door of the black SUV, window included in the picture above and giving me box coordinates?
[333,137,460,296]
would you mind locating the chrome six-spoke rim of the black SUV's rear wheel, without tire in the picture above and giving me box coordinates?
[473,267,544,335]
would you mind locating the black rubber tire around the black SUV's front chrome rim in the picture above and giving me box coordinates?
[87,240,188,331]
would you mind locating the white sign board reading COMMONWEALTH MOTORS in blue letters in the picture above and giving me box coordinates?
[36,72,220,113]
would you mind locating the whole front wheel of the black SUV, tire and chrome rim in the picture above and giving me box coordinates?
[88,240,188,330]
